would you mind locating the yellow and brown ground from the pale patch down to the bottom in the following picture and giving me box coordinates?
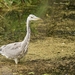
[0,37,75,75]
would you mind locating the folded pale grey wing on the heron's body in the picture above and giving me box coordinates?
[0,42,22,58]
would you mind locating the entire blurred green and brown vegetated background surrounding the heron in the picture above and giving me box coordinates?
[0,0,75,75]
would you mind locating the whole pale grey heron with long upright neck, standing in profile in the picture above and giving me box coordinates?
[0,14,40,64]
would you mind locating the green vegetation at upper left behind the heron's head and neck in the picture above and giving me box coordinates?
[0,0,47,44]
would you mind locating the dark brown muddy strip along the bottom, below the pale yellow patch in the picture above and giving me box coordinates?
[0,57,75,75]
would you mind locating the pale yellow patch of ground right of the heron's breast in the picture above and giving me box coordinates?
[26,37,75,60]
